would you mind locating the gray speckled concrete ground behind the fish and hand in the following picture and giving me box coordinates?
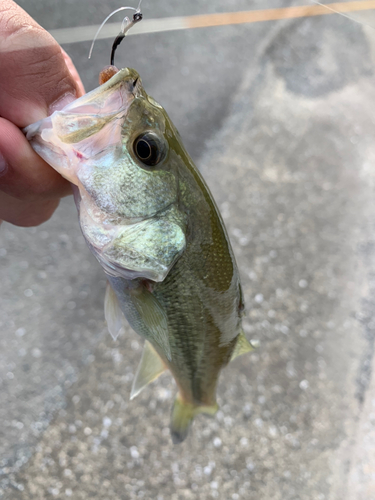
[0,0,375,500]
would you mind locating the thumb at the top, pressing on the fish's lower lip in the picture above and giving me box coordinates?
[0,0,83,127]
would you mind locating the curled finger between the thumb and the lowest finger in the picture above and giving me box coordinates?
[0,118,71,201]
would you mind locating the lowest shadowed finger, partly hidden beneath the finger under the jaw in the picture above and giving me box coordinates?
[0,192,59,227]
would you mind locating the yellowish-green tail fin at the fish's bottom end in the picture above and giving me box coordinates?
[171,394,219,444]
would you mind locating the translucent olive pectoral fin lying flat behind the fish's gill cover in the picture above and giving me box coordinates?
[131,288,172,361]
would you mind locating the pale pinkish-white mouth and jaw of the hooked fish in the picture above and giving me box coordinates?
[23,68,143,185]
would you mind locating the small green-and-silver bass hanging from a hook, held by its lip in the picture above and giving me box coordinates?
[25,68,252,443]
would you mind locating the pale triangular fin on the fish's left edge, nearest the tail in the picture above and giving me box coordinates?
[130,340,166,399]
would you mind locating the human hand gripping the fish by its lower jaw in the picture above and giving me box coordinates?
[0,0,85,226]
